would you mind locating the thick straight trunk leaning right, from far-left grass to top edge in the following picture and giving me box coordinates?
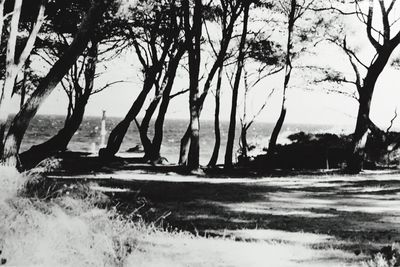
[2,0,106,166]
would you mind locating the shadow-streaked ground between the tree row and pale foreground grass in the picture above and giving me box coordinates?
[47,171,400,266]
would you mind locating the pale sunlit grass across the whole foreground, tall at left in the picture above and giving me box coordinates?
[0,167,393,267]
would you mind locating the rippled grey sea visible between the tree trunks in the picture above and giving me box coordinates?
[21,115,349,164]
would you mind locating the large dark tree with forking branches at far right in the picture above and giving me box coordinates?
[318,0,400,173]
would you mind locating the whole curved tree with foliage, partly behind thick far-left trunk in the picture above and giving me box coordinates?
[20,1,121,168]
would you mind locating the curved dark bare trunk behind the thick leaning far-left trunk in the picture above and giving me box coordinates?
[20,43,97,169]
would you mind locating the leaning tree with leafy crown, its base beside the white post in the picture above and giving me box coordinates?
[99,0,180,158]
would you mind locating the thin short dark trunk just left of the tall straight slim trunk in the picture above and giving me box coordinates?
[208,67,223,167]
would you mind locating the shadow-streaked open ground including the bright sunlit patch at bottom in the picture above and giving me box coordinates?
[46,166,400,266]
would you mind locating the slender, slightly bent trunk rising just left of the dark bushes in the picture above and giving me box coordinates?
[267,0,297,158]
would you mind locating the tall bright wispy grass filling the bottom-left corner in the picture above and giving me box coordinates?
[0,167,164,266]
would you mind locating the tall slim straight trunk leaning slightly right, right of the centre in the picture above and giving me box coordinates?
[224,2,250,168]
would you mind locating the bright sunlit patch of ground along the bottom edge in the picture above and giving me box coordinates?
[128,231,356,267]
